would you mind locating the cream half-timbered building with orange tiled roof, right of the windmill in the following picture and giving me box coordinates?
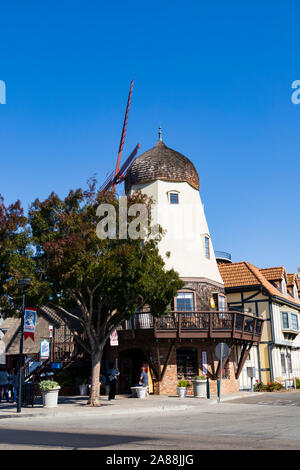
[219,261,300,389]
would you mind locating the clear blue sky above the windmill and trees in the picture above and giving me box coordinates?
[0,0,300,272]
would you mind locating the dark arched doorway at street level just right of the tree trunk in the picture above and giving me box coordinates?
[119,348,146,393]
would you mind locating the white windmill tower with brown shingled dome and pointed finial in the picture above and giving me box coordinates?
[125,129,223,309]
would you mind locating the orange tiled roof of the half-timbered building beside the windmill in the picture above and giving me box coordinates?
[218,261,300,307]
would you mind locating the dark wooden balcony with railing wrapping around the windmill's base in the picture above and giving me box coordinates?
[118,311,263,343]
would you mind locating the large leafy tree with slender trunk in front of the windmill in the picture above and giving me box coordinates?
[28,181,183,406]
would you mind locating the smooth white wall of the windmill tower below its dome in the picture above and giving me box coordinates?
[131,180,223,285]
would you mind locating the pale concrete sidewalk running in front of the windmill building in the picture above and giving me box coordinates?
[0,392,263,419]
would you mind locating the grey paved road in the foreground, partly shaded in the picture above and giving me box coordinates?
[0,394,300,451]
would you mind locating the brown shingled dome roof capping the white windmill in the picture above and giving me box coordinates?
[125,140,199,193]
